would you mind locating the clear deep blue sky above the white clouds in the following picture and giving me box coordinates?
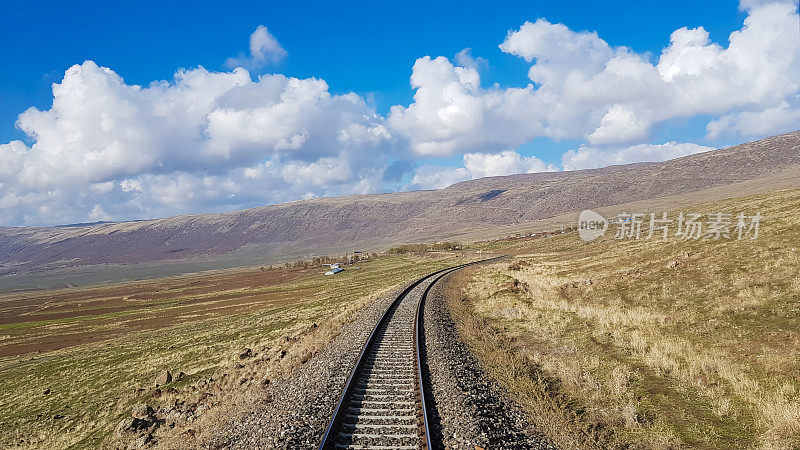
[0,1,745,156]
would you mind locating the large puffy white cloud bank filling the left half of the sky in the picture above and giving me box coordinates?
[0,61,393,224]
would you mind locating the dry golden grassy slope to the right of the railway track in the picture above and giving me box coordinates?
[450,190,800,449]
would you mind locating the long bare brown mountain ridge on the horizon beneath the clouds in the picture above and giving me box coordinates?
[0,132,800,275]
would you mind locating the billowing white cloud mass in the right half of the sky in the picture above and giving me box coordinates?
[389,2,800,149]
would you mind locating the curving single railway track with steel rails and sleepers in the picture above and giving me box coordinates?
[319,263,494,449]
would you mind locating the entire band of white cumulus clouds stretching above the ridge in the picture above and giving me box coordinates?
[0,0,800,225]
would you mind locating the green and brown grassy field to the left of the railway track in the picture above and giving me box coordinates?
[0,254,460,448]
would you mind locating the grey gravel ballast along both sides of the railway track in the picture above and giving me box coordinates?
[209,266,554,450]
